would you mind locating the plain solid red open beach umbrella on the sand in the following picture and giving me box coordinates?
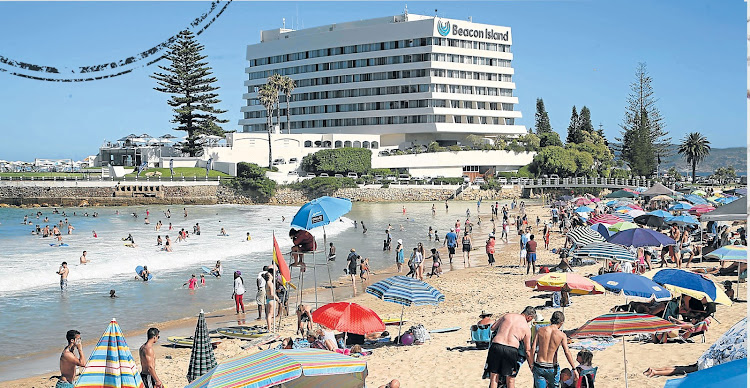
[312,302,385,335]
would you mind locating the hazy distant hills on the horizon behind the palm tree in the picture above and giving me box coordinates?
[615,144,747,173]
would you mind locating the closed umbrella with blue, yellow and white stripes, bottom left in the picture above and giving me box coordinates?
[75,318,143,388]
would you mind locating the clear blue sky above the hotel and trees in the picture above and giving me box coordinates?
[0,0,747,160]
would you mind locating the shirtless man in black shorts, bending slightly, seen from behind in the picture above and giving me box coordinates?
[485,306,536,388]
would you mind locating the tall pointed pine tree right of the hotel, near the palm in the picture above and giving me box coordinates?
[616,63,672,175]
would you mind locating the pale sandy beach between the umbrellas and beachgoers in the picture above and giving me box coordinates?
[0,206,747,388]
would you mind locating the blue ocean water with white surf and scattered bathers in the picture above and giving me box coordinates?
[0,201,520,380]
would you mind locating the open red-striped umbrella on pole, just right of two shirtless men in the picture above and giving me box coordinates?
[570,312,679,388]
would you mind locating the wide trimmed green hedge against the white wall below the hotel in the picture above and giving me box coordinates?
[301,148,372,175]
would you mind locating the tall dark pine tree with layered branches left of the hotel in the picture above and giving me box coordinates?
[151,30,229,156]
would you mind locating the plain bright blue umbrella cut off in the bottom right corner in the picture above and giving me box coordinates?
[664,358,747,388]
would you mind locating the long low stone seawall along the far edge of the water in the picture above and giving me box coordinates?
[0,185,521,207]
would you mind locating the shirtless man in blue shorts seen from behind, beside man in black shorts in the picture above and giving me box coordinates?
[529,311,577,388]
